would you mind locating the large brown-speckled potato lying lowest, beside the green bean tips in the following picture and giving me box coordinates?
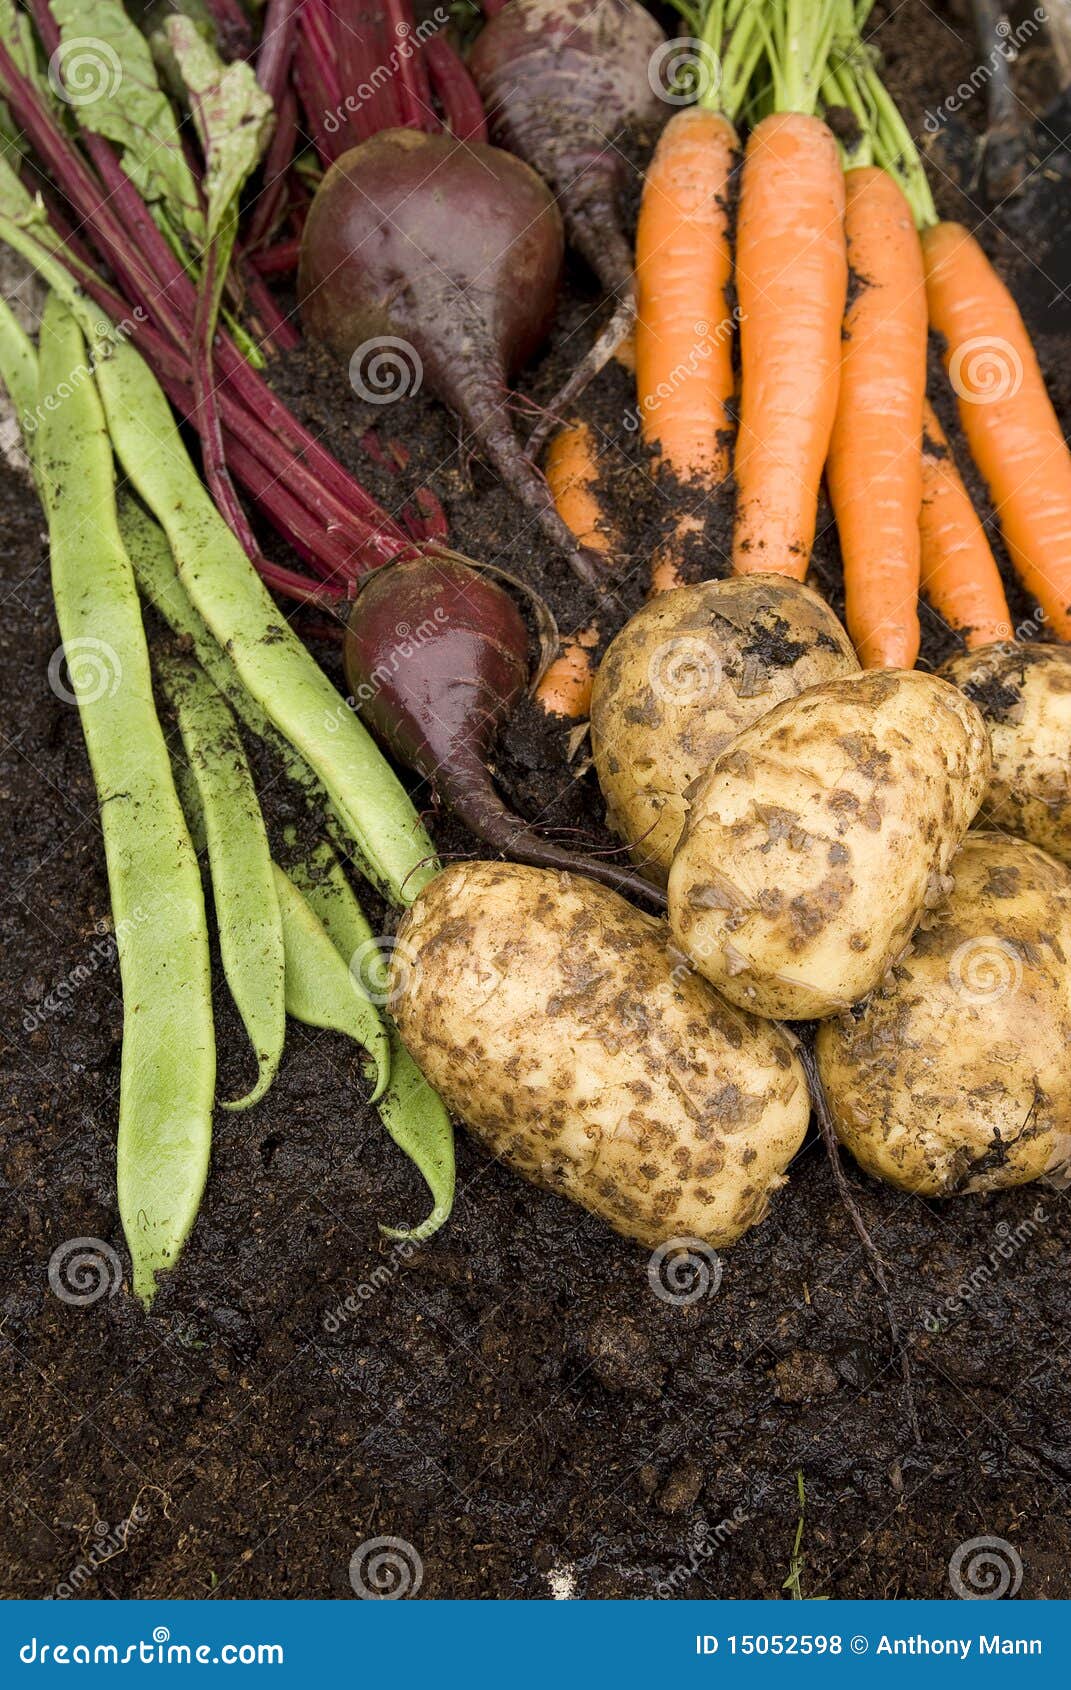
[390,862,809,1246]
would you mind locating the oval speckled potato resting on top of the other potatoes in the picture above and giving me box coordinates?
[669,669,990,1019]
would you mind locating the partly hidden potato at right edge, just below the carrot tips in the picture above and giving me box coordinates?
[939,641,1071,862]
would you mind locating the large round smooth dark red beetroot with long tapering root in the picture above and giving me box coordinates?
[299,128,600,581]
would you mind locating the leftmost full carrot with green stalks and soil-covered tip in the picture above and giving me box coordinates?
[635,0,764,592]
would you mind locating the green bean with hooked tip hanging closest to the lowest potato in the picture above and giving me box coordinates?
[291,845,454,1240]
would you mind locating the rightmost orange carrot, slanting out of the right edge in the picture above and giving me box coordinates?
[922,223,1071,639]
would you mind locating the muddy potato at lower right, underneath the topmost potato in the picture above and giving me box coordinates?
[818,833,1071,1197]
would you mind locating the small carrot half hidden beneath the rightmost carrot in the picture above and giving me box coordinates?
[919,401,1012,651]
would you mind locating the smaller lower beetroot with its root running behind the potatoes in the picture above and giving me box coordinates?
[345,556,664,904]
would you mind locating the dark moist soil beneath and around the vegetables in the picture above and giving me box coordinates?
[0,0,1071,1597]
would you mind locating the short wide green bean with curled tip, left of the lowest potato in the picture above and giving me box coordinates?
[272,864,390,1104]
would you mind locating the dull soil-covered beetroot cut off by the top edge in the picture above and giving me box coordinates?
[468,0,667,299]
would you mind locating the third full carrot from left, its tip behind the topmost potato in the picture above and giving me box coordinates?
[826,166,926,669]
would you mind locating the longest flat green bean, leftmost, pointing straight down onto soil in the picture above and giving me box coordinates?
[37,296,216,1306]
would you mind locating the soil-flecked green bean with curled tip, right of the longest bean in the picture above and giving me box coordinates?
[157,657,285,1109]
